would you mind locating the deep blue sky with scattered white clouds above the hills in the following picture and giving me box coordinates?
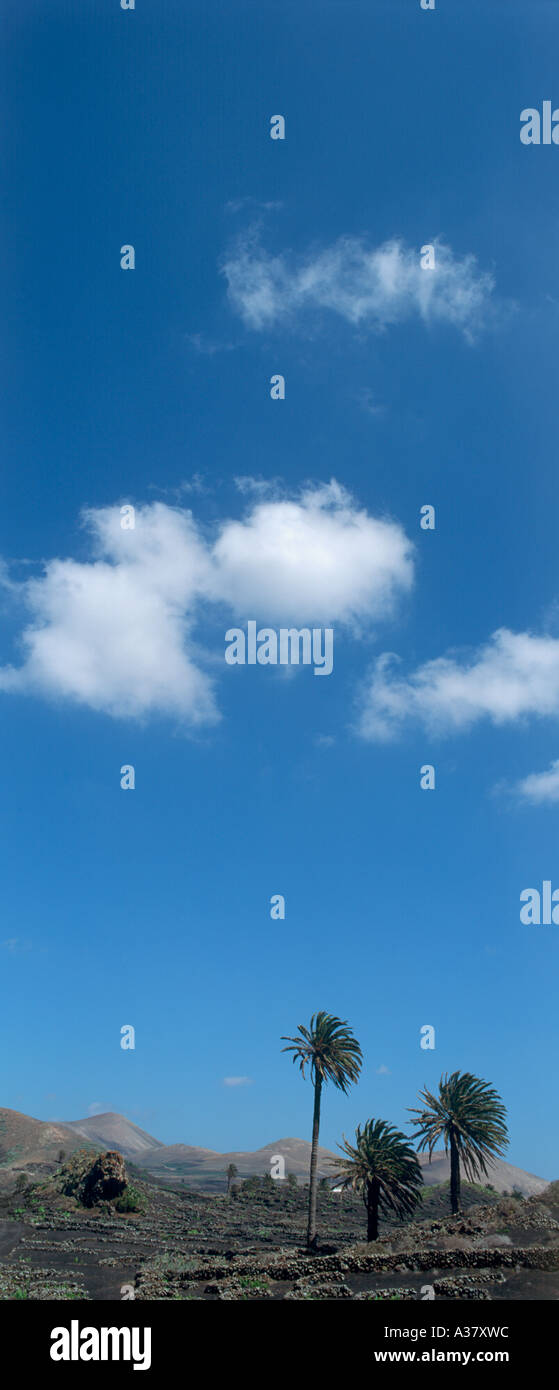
[0,0,559,1177]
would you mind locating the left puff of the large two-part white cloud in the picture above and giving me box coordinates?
[0,503,217,723]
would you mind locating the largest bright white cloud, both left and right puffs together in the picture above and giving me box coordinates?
[0,482,413,724]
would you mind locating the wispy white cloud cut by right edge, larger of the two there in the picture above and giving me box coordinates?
[357,628,559,739]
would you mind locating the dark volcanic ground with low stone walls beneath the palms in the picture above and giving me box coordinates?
[0,1177,559,1301]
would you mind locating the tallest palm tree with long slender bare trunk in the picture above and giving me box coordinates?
[281,1012,363,1250]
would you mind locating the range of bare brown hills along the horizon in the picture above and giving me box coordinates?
[0,1109,548,1197]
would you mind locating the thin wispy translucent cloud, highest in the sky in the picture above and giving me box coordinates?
[222,235,494,338]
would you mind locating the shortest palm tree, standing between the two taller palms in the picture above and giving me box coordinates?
[332,1120,423,1240]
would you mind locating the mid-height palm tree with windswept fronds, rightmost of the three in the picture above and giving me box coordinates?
[410,1072,509,1216]
